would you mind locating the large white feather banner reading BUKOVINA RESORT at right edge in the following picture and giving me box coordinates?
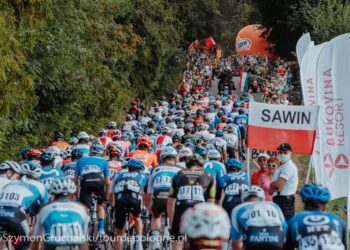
[317,34,350,199]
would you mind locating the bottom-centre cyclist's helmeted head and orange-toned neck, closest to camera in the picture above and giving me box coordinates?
[180,203,230,250]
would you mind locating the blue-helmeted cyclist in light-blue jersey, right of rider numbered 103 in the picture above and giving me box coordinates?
[40,152,64,190]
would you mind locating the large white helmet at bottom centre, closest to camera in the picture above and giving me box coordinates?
[180,203,231,244]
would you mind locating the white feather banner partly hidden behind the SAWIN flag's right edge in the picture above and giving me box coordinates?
[300,43,327,183]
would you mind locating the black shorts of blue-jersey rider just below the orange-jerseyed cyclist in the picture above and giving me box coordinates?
[114,193,141,230]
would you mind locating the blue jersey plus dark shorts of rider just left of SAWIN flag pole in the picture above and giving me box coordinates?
[219,173,249,214]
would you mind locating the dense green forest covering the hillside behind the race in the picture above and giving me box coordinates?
[0,0,350,159]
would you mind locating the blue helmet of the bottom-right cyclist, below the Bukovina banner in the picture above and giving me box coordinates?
[300,183,331,203]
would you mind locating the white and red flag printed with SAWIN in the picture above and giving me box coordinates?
[248,102,318,155]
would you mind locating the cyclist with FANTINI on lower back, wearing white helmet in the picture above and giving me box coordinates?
[231,185,287,250]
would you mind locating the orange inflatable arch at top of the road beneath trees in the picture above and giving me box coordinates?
[235,24,274,57]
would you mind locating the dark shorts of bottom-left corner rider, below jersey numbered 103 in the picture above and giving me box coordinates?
[0,206,30,249]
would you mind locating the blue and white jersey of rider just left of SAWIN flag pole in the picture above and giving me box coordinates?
[219,173,250,197]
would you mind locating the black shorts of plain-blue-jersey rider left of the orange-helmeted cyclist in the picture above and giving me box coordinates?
[79,174,106,208]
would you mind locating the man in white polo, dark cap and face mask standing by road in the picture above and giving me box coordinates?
[269,143,298,221]
